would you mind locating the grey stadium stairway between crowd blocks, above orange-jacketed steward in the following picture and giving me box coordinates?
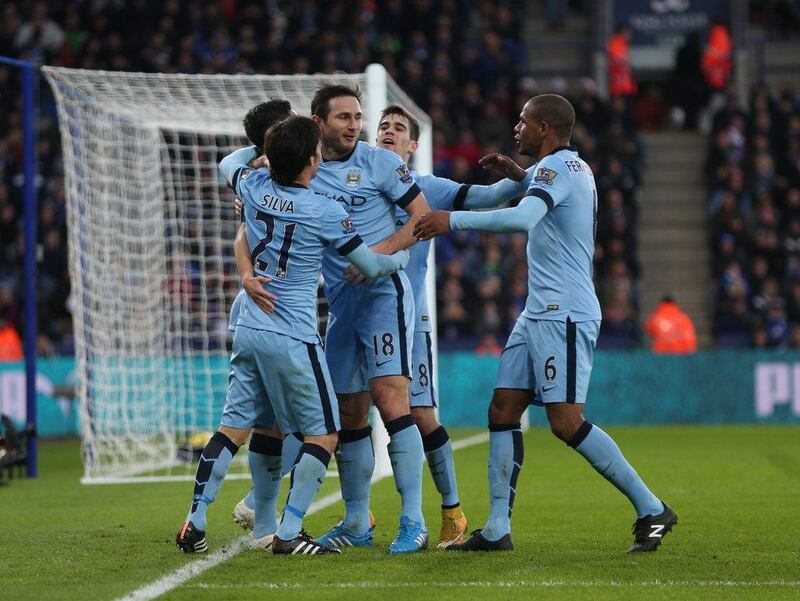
[637,131,711,347]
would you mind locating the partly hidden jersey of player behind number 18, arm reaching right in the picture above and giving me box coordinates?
[394,171,462,332]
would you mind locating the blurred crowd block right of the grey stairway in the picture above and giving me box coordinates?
[706,86,800,347]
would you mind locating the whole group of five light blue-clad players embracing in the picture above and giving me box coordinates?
[176,85,677,555]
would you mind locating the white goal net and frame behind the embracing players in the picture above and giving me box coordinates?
[43,65,435,482]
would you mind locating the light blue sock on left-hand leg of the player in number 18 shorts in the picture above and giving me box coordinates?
[336,426,375,534]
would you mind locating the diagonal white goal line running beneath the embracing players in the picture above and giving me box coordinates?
[119,432,489,601]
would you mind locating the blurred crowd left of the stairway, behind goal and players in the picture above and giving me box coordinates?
[0,0,643,355]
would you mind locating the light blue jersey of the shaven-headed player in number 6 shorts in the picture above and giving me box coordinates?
[523,146,600,322]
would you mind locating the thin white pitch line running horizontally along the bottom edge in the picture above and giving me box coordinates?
[181,580,800,590]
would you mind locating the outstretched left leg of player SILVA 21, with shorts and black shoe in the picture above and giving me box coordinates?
[176,331,263,553]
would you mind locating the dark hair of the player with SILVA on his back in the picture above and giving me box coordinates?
[264,116,320,186]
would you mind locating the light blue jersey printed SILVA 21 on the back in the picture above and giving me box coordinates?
[225,162,363,343]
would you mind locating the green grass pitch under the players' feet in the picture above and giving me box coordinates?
[0,426,800,601]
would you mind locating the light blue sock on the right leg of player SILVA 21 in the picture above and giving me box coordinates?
[276,443,331,540]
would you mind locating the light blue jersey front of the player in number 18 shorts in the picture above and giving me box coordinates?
[311,142,420,302]
